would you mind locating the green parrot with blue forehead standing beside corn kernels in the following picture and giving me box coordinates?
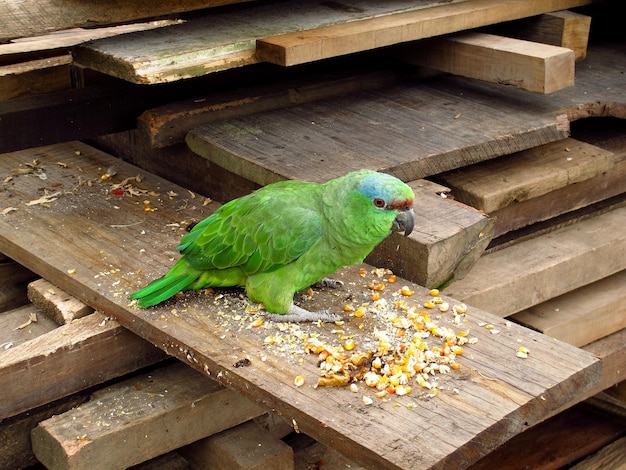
[130,170,415,321]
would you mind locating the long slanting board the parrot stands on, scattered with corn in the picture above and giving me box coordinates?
[0,143,601,468]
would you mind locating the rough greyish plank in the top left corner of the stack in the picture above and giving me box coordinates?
[0,0,251,42]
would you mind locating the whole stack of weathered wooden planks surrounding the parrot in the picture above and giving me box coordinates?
[0,0,626,469]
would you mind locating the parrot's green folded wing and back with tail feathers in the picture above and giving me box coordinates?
[130,181,322,307]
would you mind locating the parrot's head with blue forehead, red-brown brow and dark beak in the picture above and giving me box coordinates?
[354,170,415,236]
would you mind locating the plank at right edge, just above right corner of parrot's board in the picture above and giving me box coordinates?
[511,271,626,346]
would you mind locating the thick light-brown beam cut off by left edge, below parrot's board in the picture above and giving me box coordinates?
[0,313,165,419]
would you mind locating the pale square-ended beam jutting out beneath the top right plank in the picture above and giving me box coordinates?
[395,32,574,94]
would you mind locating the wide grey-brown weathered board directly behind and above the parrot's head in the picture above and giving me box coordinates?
[187,37,626,184]
